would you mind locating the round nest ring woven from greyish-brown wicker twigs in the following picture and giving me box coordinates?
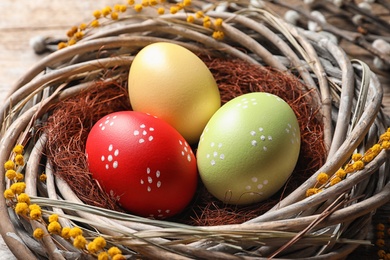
[0,2,390,259]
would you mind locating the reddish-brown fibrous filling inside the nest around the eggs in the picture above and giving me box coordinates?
[43,57,326,226]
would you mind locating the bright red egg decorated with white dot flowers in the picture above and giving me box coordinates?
[86,111,198,218]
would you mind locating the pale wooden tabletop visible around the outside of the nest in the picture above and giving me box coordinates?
[0,0,390,260]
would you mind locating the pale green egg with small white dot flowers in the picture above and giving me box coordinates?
[197,92,301,205]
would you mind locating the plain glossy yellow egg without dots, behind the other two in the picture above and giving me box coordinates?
[128,42,221,144]
